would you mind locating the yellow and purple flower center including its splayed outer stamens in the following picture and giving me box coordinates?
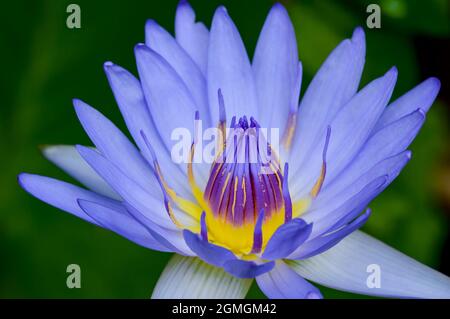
[146,99,331,260]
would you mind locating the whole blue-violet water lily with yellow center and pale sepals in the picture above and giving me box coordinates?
[19,1,450,298]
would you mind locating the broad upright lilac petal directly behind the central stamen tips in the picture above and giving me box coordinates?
[207,7,258,124]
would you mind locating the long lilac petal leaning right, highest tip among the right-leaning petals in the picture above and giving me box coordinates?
[290,28,365,180]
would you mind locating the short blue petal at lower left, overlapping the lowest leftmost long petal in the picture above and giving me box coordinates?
[78,199,171,252]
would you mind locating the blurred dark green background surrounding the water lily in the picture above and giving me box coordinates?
[0,0,450,298]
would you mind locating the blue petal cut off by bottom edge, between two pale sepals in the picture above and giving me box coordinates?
[256,260,322,299]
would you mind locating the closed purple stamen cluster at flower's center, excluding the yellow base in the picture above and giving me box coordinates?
[204,116,283,227]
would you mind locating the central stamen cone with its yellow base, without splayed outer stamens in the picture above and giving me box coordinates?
[203,117,292,255]
